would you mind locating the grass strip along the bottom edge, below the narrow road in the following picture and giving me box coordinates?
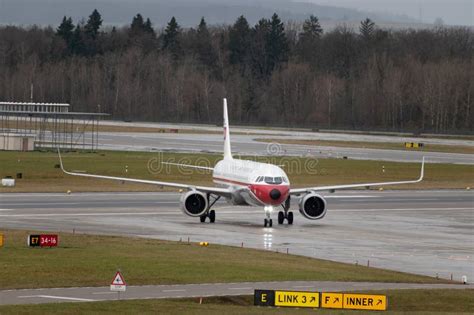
[0,290,474,314]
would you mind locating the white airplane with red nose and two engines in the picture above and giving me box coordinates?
[58,99,425,227]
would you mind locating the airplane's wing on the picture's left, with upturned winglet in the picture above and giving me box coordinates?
[58,149,231,197]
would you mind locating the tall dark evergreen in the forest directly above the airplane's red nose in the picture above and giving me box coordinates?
[266,13,289,72]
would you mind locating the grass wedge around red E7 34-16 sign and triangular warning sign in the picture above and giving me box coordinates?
[0,230,449,289]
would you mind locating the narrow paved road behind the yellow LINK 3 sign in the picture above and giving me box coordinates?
[0,281,474,304]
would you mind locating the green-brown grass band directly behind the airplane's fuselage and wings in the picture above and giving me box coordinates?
[0,151,474,192]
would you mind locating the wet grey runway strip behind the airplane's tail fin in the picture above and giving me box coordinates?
[99,132,474,165]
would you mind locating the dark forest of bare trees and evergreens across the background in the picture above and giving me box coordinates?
[0,10,474,133]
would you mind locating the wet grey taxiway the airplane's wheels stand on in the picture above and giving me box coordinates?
[0,191,474,280]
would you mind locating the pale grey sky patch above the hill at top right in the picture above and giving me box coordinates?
[310,0,474,26]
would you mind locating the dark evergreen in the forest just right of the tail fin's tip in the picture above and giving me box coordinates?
[228,15,251,64]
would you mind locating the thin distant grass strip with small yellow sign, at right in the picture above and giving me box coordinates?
[255,138,474,154]
